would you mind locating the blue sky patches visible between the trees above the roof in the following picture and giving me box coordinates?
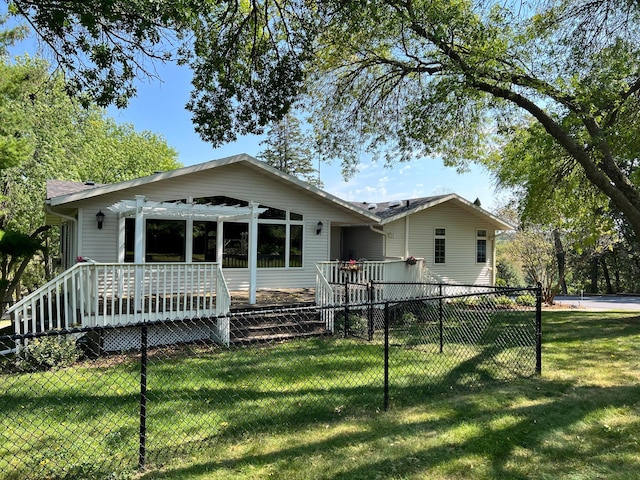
[6,16,500,210]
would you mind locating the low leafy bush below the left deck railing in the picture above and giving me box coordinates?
[16,337,82,372]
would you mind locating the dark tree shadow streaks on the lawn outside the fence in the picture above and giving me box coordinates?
[141,380,640,479]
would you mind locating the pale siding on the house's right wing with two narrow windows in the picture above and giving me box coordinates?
[385,202,494,285]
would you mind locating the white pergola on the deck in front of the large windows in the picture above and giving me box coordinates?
[108,195,267,303]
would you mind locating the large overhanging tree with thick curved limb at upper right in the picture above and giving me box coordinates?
[13,0,640,244]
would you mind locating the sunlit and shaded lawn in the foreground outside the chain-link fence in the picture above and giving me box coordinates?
[136,312,640,480]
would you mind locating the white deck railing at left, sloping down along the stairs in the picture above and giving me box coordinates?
[7,262,231,339]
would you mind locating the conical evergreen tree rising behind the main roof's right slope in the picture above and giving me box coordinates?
[258,114,322,188]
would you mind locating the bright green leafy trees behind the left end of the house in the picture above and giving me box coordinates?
[0,53,179,316]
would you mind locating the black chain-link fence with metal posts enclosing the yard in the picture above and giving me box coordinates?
[0,284,541,479]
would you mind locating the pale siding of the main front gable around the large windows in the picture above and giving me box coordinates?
[65,163,372,290]
